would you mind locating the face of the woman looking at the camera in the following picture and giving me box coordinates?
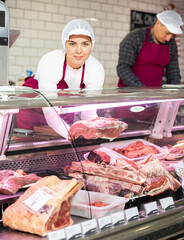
[65,35,92,69]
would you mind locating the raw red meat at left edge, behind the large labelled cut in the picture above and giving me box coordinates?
[0,169,40,195]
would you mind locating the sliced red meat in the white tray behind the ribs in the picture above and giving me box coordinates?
[113,141,159,158]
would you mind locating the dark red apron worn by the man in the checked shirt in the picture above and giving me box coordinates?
[118,28,170,87]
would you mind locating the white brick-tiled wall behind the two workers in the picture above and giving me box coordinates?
[6,0,184,87]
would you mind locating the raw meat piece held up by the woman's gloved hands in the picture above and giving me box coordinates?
[69,117,128,140]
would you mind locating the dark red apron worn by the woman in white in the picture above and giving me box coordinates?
[17,57,85,130]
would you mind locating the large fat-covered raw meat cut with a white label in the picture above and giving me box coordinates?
[2,175,83,236]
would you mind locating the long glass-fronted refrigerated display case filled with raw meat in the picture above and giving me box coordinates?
[0,86,184,239]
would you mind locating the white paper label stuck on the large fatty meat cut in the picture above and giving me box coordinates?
[24,189,52,212]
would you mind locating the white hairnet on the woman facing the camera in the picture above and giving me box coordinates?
[62,19,95,49]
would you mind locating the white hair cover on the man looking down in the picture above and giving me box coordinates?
[157,10,183,34]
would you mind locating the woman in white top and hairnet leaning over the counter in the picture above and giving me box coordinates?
[17,19,104,138]
